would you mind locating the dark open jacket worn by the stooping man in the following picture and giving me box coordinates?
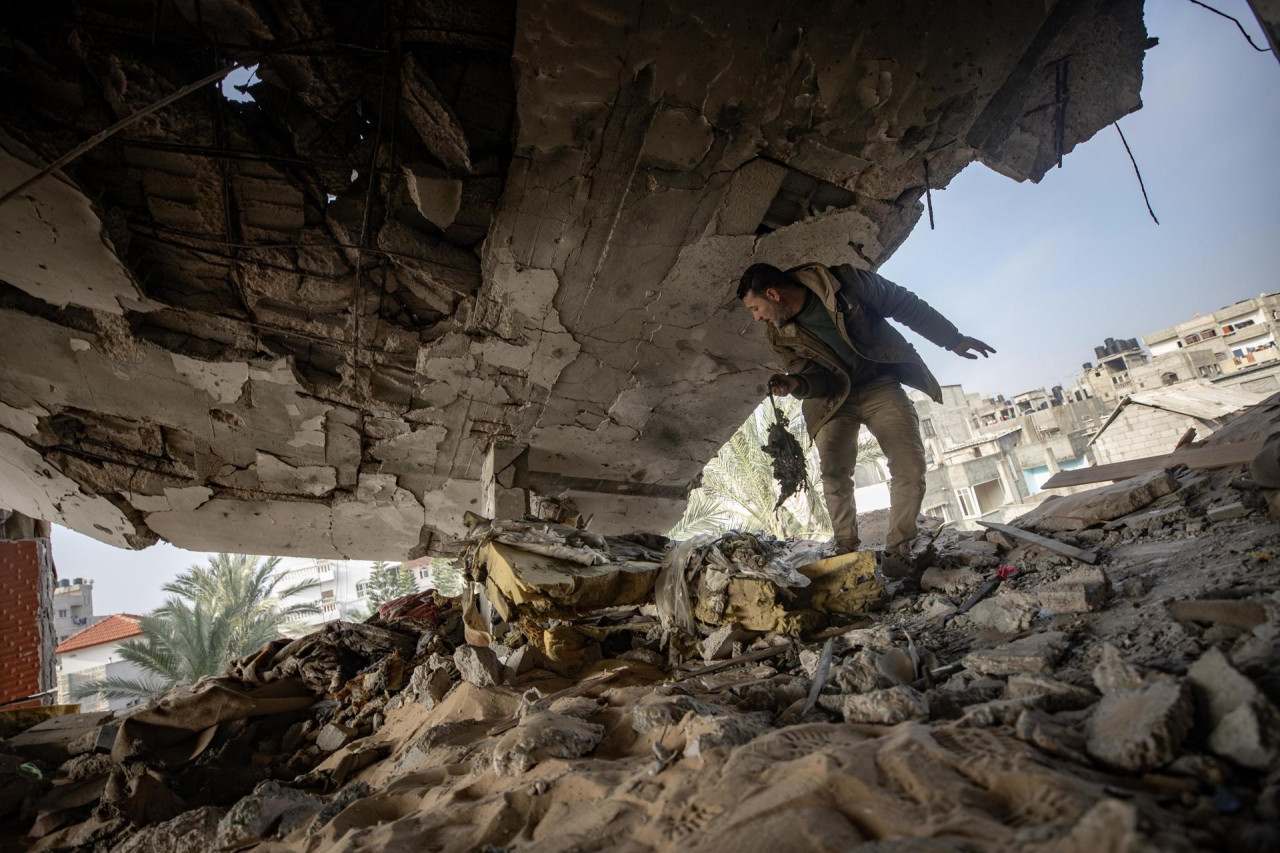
[768,264,964,435]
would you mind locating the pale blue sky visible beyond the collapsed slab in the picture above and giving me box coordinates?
[54,0,1280,613]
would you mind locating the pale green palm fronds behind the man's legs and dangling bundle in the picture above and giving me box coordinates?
[671,397,883,539]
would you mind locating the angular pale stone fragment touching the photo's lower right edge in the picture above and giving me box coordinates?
[1187,648,1280,770]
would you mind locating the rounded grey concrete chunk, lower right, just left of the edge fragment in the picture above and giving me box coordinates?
[1085,679,1196,771]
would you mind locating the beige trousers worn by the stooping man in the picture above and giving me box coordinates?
[814,377,925,555]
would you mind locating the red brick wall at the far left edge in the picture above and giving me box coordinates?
[0,538,56,708]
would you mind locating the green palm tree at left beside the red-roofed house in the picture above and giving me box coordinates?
[76,553,319,699]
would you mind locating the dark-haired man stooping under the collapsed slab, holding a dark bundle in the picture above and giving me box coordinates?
[737,264,995,576]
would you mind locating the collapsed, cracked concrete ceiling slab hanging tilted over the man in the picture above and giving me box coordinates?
[0,0,1148,558]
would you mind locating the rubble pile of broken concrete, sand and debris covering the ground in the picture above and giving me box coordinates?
[0,450,1280,853]
